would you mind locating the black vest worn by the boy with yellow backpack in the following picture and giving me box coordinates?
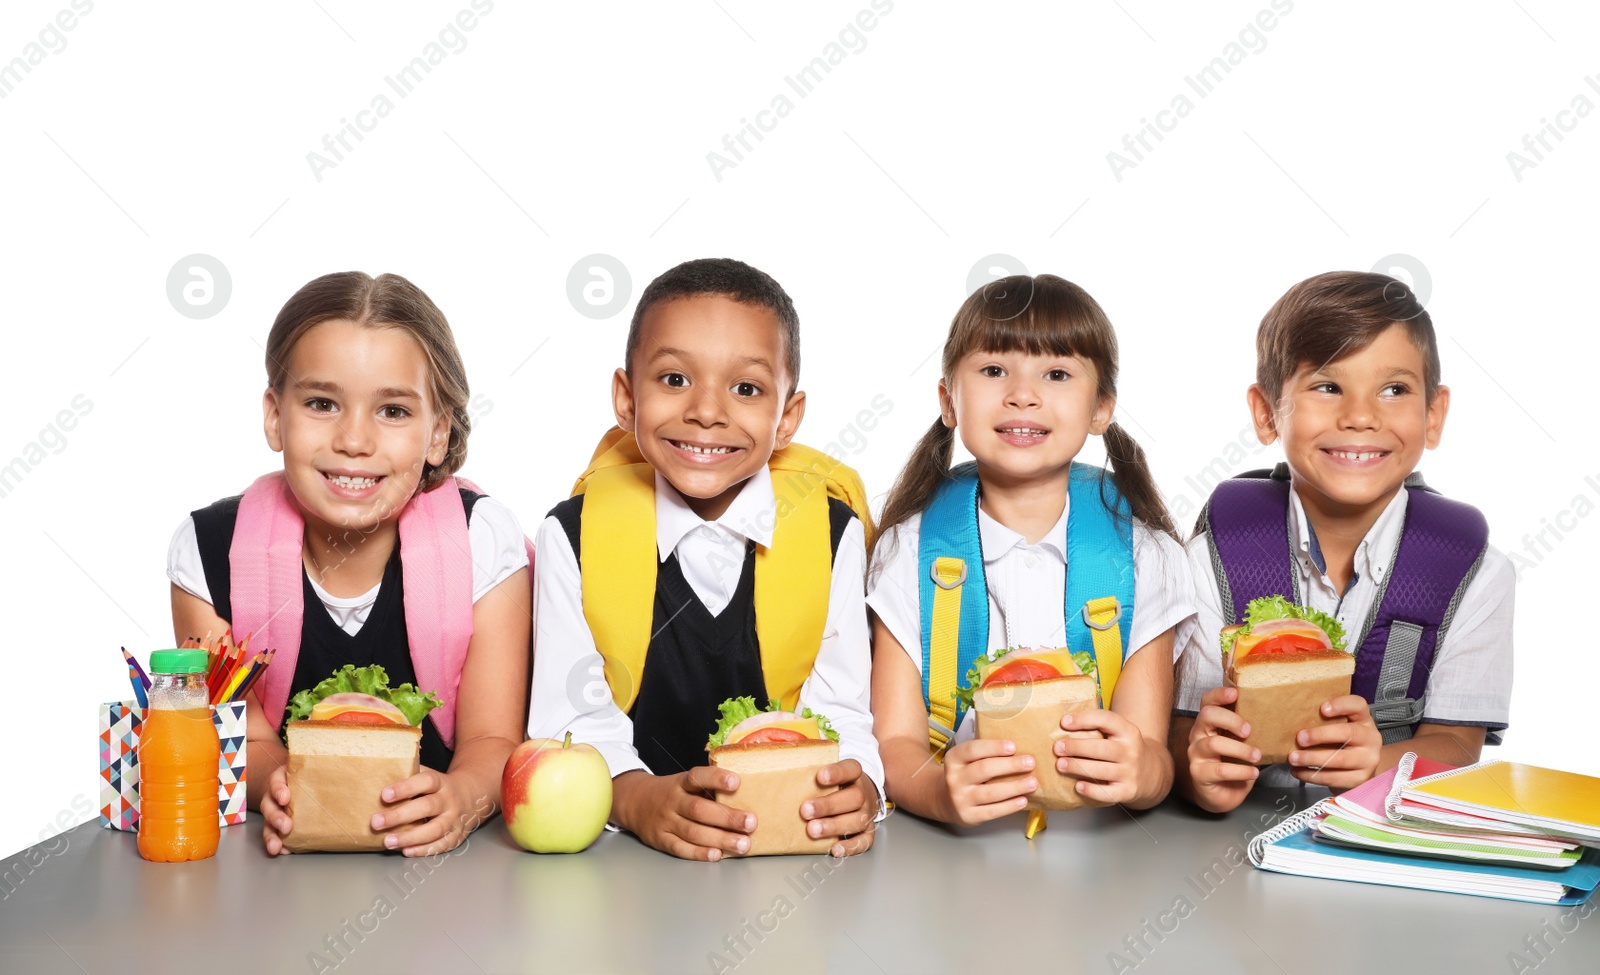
[550,495,856,775]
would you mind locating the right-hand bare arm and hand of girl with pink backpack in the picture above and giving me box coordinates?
[373,568,533,857]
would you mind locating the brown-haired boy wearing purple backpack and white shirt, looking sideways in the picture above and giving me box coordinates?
[1168,272,1515,812]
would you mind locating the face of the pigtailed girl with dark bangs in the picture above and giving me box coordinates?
[939,352,1117,483]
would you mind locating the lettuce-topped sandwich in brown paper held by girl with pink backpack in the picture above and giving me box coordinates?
[283,664,438,853]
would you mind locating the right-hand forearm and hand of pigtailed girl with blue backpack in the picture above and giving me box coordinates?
[1056,628,1174,808]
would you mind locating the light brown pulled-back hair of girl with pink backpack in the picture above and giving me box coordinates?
[267,271,472,492]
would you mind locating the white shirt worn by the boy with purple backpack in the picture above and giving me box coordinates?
[1174,490,1517,784]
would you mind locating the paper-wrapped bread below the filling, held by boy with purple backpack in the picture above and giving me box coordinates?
[1222,650,1355,765]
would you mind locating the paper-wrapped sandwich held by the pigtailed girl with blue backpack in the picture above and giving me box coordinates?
[955,647,1101,813]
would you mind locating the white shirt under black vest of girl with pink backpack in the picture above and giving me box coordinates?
[166,498,528,636]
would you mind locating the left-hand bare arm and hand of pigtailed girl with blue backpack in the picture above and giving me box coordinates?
[872,615,1038,826]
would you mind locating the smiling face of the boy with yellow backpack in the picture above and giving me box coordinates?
[611,295,805,520]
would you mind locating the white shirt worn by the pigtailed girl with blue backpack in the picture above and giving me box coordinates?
[867,503,1195,743]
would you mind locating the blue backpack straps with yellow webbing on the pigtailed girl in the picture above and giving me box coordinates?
[917,463,1134,754]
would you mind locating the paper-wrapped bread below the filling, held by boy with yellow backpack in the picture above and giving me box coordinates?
[710,738,838,857]
